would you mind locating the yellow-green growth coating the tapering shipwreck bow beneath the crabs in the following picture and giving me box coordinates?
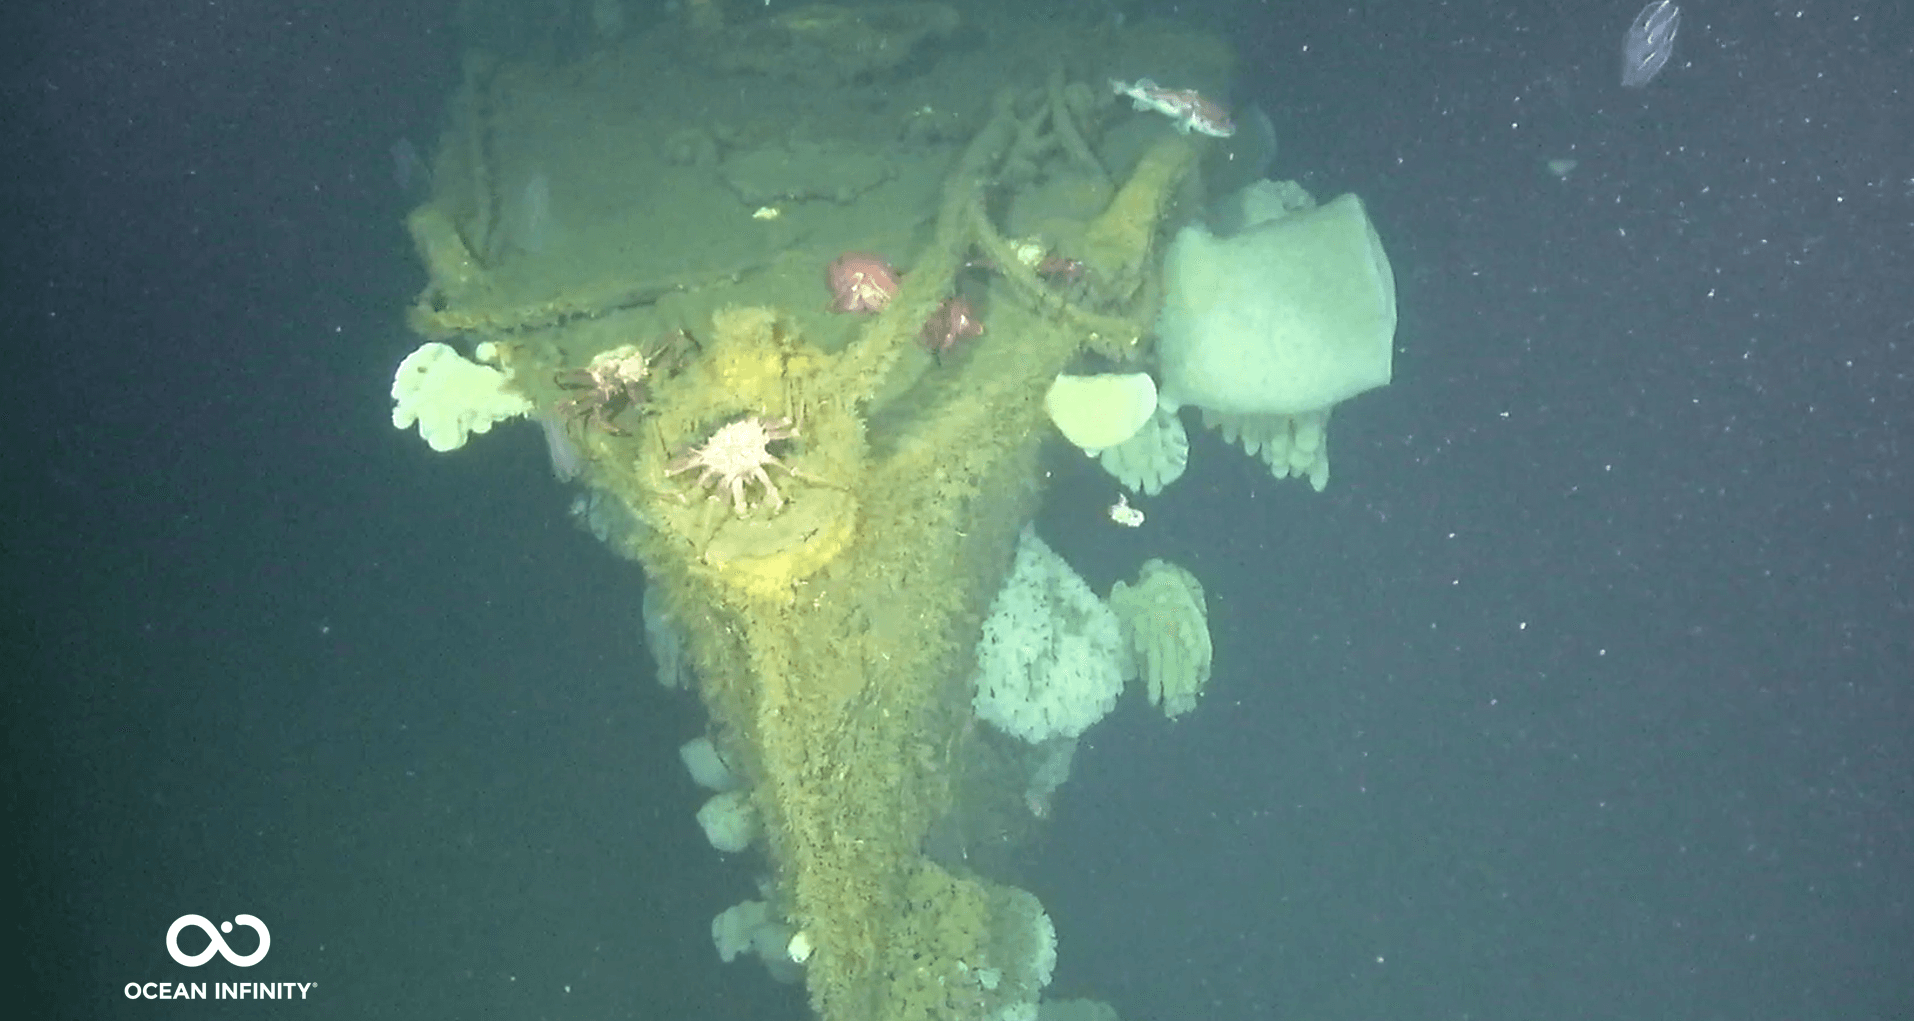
[410,10,1227,1021]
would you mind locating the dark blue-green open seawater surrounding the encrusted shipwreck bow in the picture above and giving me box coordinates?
[0,2,1914,1019]
